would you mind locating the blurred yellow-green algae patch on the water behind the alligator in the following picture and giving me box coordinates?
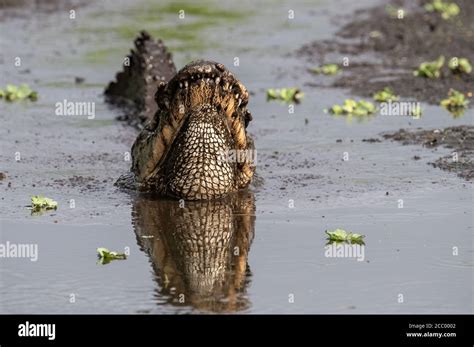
[80,1,244,57]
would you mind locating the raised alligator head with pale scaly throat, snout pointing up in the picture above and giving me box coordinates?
[127,61,255,200]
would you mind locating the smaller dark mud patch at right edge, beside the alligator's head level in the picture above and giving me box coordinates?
[383,126,474,181]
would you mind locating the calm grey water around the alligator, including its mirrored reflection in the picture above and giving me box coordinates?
[0,1,474,313]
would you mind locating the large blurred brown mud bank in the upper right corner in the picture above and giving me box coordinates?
[297,0,474,104]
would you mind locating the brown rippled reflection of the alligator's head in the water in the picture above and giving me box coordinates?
[133,192,255,312]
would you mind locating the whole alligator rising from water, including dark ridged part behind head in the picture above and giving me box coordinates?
[105,32,255,200]
